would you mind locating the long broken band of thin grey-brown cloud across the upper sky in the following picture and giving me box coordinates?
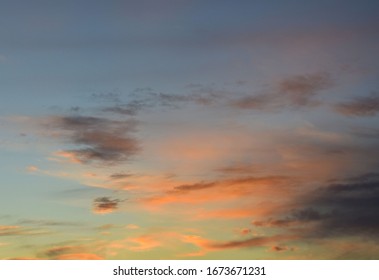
[100,72,335,116]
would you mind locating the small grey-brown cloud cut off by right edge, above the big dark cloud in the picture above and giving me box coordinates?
[334,92,379,117]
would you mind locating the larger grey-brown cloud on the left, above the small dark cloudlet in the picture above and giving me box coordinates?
[53,116,140,164]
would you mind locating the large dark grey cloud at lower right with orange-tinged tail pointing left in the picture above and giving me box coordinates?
[253,173,379,238]
